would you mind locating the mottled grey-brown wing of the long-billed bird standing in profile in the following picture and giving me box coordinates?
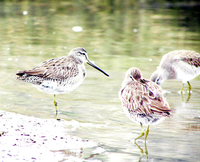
[17,57,78,79]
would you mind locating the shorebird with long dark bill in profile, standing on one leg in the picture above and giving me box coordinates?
[16,47,109,115]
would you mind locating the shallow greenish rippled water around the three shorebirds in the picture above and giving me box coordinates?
[0,1,200,161]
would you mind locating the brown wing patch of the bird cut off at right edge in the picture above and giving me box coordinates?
[180,51,200,67]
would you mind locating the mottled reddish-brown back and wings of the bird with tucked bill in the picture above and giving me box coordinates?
[121,81,170,115]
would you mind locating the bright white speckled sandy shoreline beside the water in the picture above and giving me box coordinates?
[0,111,106,162]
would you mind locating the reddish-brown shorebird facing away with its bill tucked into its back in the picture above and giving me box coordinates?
[118,67,171,142]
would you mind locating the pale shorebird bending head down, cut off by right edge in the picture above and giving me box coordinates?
[150,50,200,94]
